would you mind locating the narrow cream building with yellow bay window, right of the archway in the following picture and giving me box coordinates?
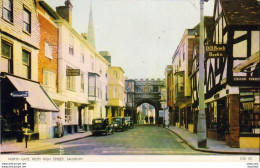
[172,29,196,130]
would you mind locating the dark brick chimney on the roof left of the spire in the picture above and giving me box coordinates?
[56,0,73,25]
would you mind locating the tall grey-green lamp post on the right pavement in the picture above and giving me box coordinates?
[197,0,208,148]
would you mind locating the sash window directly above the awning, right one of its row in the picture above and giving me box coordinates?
[22,50,31,79]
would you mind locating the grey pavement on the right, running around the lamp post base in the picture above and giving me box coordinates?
[165,126,260,155]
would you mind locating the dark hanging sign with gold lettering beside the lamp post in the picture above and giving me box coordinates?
[205,45,227,58]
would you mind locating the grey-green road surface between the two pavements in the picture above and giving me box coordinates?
[20,125,215,155]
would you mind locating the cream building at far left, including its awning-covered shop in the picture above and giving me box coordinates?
[0,0,58,141]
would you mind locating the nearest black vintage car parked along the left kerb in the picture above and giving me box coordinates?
[90,118,114,135]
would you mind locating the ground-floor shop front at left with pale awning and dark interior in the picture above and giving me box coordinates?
[1,74,59,141]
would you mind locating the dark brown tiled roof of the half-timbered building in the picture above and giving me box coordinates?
[220,0,260,26]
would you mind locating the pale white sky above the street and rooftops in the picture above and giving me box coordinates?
[45,0,214,79]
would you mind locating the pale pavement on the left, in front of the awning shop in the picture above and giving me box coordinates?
[0,131,92,154]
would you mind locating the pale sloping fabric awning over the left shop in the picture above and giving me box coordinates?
[7,75,59,112]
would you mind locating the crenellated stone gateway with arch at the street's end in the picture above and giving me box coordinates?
[125,78,165,122]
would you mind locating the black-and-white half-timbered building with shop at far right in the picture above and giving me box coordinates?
[204,0,260,148]
